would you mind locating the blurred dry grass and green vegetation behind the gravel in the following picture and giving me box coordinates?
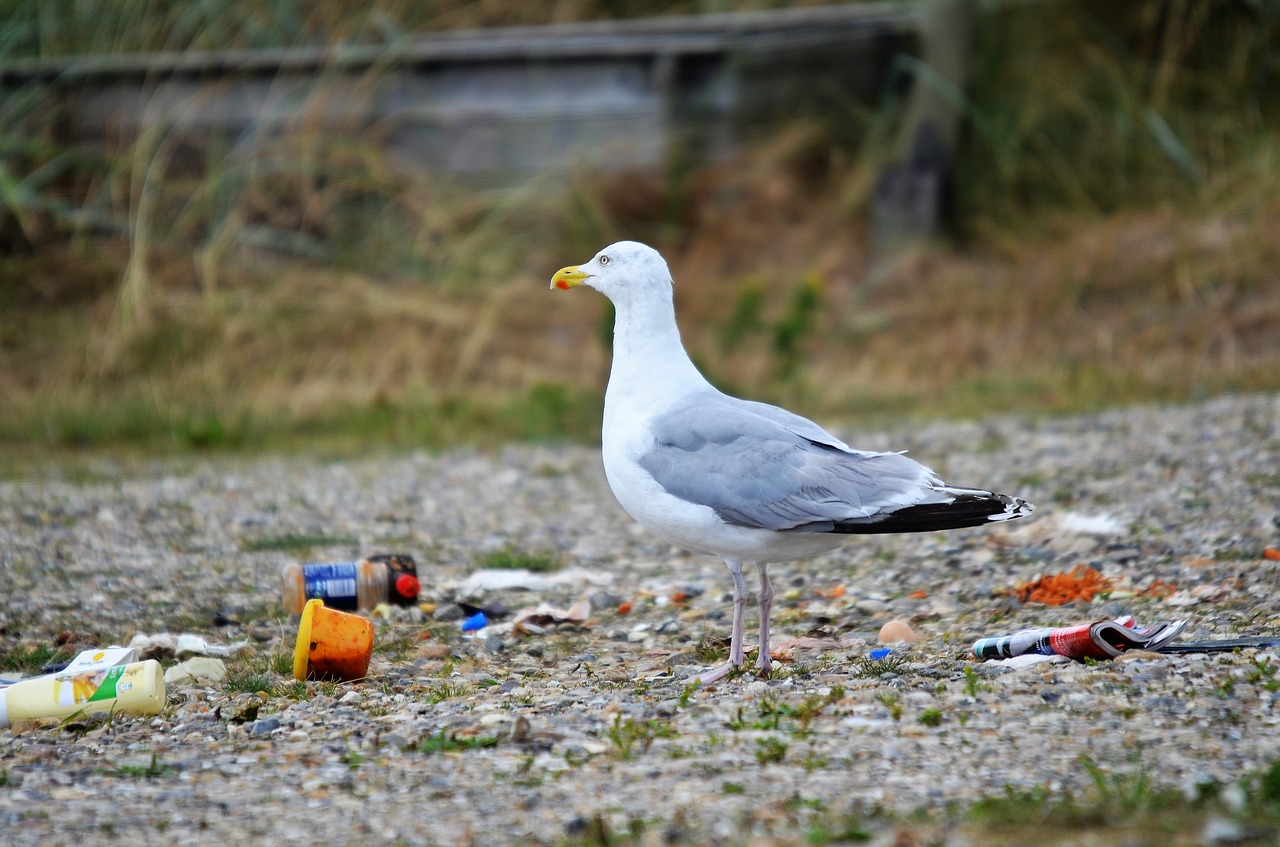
[0,0,1280,450]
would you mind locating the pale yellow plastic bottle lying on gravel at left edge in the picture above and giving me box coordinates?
[0,659,164,727]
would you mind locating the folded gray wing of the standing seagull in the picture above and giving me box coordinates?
[639,393,950,532]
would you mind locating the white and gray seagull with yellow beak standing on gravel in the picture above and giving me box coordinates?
[552,241,1034,685]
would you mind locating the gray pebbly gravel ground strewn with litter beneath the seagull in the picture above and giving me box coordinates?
[0,395,1280,846]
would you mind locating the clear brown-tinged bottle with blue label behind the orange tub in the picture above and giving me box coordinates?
[280,553,419,614]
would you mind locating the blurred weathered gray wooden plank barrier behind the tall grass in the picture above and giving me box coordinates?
[0,3,915,182]
